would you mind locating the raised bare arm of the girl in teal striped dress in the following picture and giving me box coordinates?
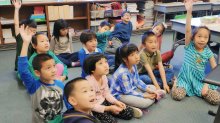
[185,0,193,45]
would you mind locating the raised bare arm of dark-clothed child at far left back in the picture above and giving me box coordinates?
[12,0,21,36]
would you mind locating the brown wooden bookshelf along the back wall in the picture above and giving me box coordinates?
[0,0,147,46]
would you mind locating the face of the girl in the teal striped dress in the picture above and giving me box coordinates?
[194,28,209,50]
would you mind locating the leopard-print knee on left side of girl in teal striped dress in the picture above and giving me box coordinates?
[172,87,186,101]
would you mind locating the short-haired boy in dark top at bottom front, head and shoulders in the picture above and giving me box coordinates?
[63,77,100,123]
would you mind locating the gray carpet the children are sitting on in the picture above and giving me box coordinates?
[0,32,218,123]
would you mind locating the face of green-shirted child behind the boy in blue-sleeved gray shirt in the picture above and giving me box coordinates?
[34,35,50,53]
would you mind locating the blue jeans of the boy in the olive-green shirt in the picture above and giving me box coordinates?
[139,68,174,88]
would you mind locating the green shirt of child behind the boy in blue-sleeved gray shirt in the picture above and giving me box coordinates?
[28,50,68,80]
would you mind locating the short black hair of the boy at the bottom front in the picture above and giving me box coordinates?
[64,77,86,100]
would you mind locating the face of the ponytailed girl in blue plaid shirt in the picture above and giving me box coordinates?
[127,51,140,65]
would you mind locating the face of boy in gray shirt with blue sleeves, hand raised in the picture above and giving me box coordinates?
[37,59,57,82]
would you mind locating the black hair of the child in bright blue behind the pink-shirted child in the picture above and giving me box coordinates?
[80,30,96,44]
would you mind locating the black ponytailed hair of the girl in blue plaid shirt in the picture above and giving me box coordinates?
[115,43,138,70]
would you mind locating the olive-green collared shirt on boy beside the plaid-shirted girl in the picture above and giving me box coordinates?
[138,49,162,73]
